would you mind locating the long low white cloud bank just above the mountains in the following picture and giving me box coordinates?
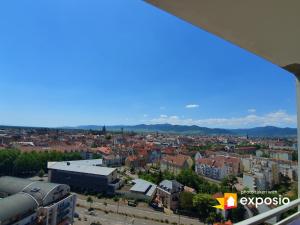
[148,110,297,128]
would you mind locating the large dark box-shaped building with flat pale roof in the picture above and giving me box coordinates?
[48,160,120,194]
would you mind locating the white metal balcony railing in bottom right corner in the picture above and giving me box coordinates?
[235,199,300,225]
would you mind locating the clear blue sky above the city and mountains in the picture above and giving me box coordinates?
[0,0,296,128]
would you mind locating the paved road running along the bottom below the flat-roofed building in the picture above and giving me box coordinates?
[77,198,203,225]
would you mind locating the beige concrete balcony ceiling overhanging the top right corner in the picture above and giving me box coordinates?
[145,0,300,75]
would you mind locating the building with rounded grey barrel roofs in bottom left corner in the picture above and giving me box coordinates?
[0,177,76,225]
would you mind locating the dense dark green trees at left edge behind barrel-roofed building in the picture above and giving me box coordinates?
[0,149,81,177]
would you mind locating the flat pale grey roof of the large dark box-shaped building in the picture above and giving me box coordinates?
[48,161,116,176]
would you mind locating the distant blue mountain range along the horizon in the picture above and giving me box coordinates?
[72,124,297,137]
